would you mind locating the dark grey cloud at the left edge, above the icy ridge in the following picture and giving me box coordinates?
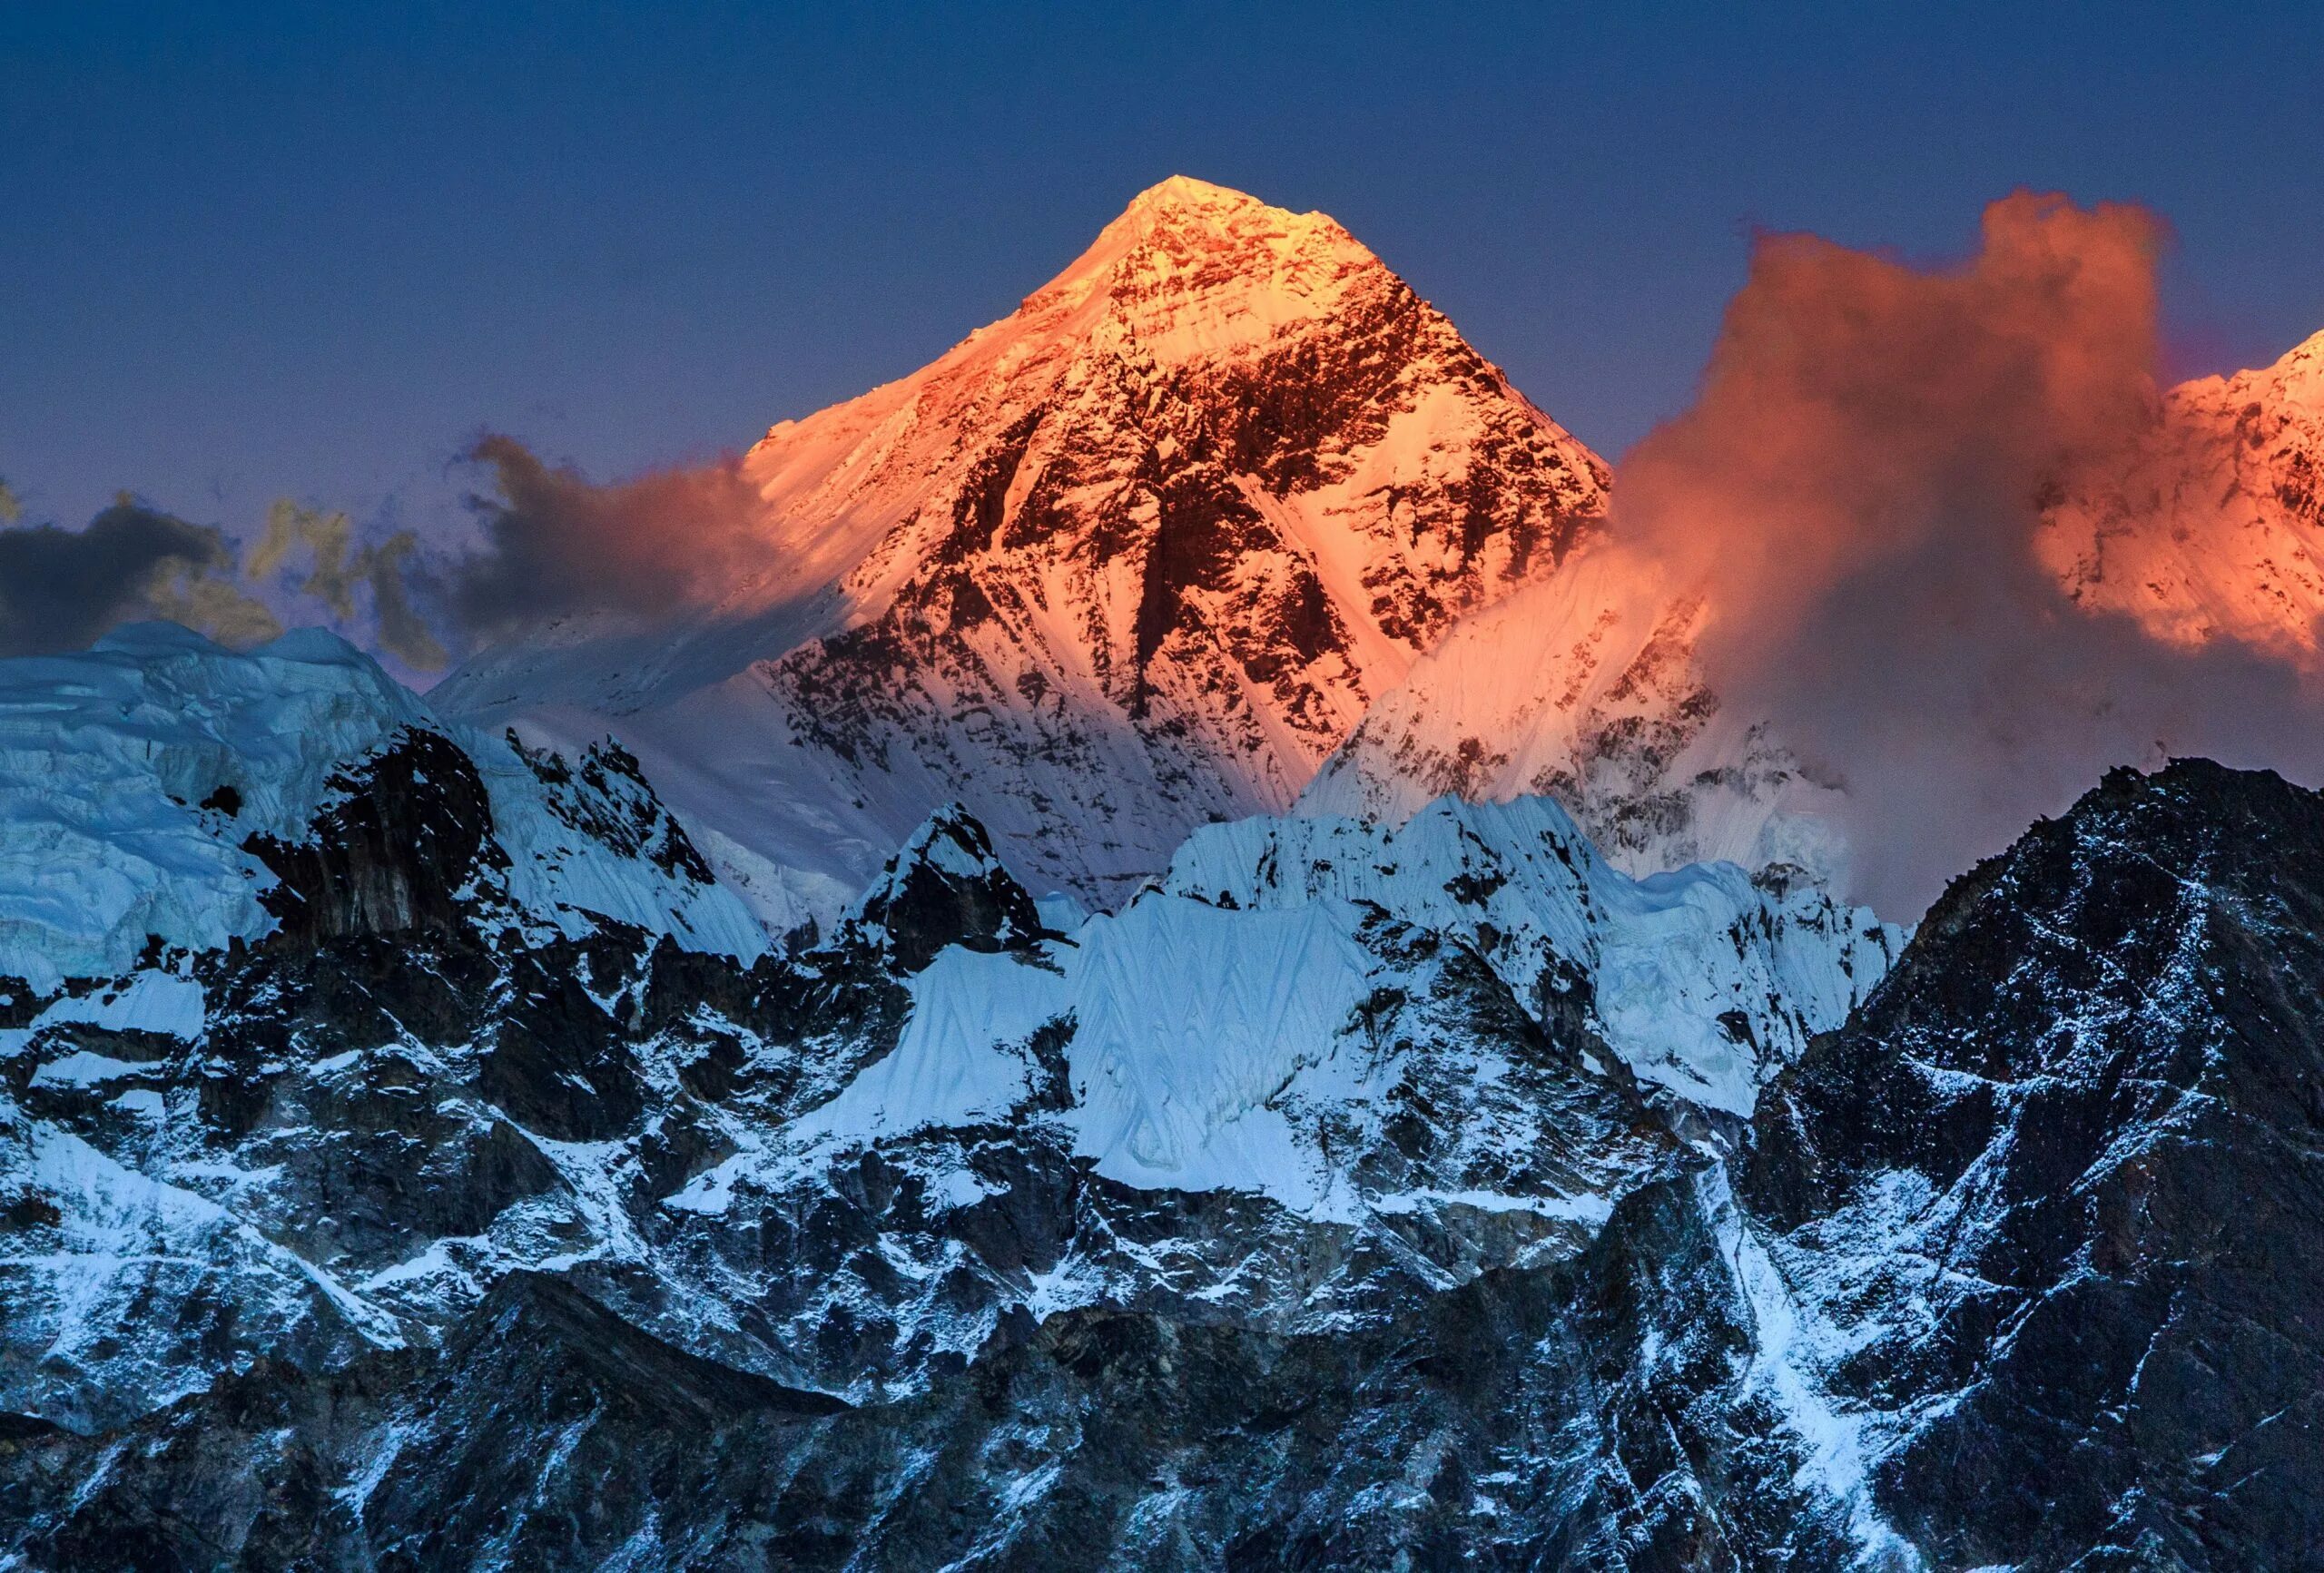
[0,497,281,655]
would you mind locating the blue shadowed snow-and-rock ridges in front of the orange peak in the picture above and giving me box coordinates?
[0,599,2324,1570]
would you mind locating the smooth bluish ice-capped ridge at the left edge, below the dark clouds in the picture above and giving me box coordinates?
[0,623,764,992]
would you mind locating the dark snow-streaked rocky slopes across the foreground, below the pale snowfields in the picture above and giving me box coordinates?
[0,758,2324,1573]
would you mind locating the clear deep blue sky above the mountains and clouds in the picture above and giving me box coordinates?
[0,0,2324,535]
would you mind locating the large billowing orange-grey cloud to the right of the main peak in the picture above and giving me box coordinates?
[1615,192,2324,910]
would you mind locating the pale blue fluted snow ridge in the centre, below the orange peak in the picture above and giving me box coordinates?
[734,797,1904,1222]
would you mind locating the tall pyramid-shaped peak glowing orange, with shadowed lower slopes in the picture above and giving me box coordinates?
[435,179,1606,901]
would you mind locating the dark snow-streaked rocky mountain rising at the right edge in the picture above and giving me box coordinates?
[1740,762,2324,1568]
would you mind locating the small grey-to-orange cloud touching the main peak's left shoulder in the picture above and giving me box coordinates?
[448,435,764,642]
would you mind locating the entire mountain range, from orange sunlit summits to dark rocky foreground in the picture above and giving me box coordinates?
[14,179,2324,1573]
